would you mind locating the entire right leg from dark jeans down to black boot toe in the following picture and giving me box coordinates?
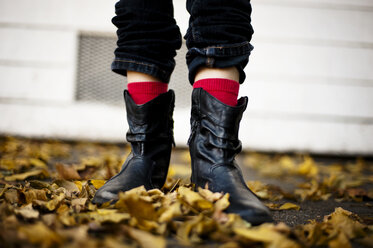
[185,0,271,225]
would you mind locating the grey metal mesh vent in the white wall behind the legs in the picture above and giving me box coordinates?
[76,33,192,108]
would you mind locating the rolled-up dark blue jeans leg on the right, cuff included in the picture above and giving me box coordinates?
[185,0,254,84]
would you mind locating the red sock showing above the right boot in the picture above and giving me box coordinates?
[193,78,240,106]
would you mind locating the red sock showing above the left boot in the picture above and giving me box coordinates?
[127,82,168,105]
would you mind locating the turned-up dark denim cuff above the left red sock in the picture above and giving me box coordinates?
[111,58,172,83]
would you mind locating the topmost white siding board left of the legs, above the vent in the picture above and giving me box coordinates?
[0,0,117,31]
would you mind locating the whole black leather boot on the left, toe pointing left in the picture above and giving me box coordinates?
[92,90,175,204]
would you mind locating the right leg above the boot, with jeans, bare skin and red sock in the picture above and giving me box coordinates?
[185,0,253,105]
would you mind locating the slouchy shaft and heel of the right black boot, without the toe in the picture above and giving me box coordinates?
[188,88,247,187]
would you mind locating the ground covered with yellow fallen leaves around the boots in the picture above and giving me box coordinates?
[0,137,373,247]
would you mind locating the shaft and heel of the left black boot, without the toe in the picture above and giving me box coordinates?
[124,90,175,188]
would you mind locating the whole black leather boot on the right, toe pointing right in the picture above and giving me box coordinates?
[188,88,272,225]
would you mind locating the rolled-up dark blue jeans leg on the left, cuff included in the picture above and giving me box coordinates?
[111,0,181,83]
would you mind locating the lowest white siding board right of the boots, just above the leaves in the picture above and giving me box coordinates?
[240,117,373,155]
